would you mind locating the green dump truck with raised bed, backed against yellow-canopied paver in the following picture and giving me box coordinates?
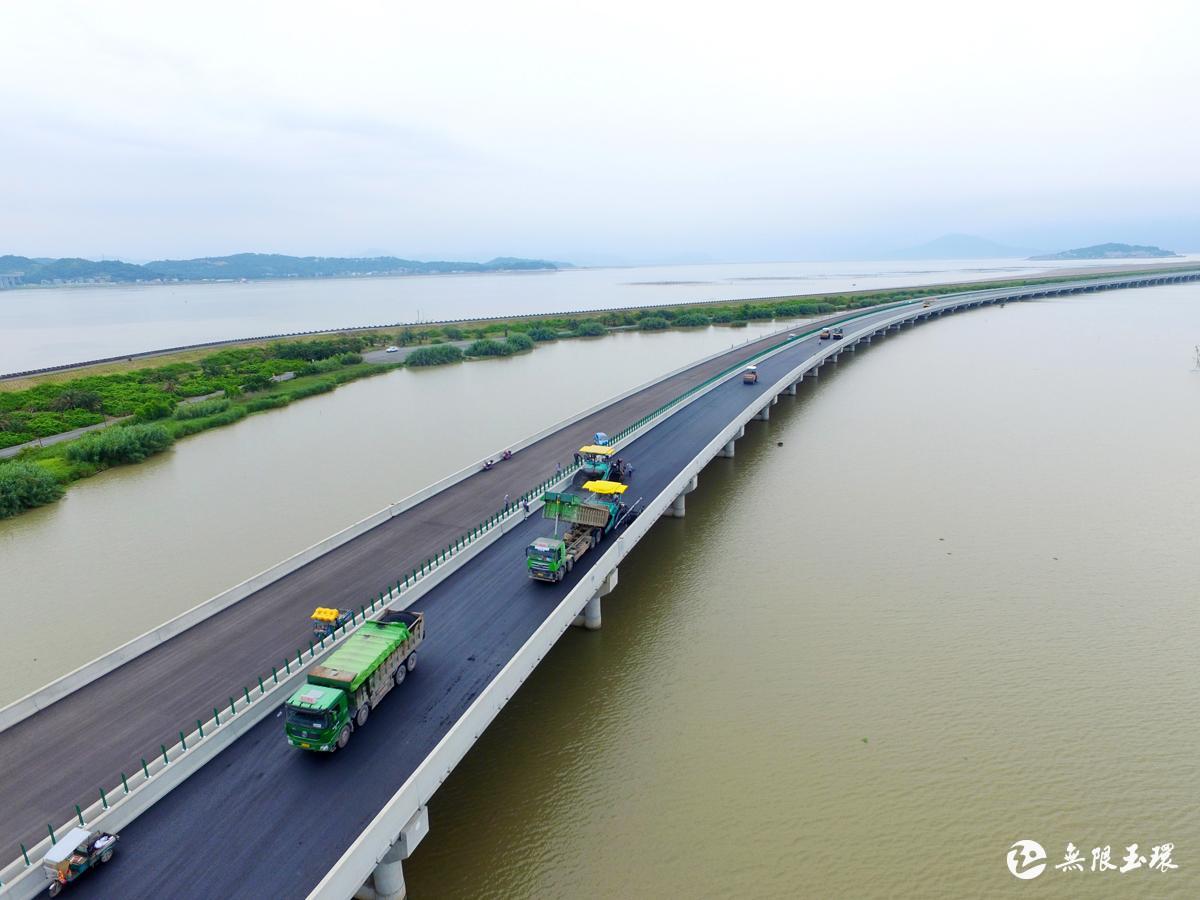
[526,481,628,582]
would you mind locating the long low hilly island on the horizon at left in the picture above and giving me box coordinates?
[0,253,574,288]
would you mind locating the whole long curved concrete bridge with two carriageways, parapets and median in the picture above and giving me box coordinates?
[0,270,1200,899]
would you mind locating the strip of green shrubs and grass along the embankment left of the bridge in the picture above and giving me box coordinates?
[0,266,1185,518]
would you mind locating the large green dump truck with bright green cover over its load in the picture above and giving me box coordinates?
[283,610,425,752]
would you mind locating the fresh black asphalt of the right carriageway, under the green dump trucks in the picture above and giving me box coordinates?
[71,297,883,900]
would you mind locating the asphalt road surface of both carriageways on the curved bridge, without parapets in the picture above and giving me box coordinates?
[0,274,1200,898]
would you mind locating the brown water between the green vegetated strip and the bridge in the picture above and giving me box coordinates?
[0,323,806,706]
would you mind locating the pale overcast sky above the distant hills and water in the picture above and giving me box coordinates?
[0,0,1200,263]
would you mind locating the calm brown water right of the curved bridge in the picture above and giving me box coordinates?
[406,286,1200,900]
